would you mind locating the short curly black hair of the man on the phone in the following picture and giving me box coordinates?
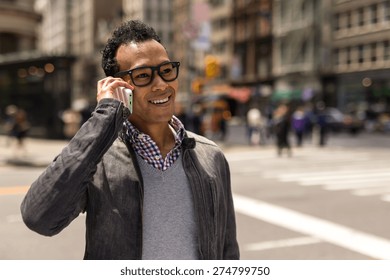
[102,20,161,76]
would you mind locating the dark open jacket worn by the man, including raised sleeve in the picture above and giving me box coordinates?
[21,99,239,259]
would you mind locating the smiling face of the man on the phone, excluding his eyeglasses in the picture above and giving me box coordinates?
[116,40,179,129]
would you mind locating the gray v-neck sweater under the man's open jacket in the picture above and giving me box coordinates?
[137,155,199,260]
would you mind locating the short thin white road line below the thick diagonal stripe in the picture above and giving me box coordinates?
[243,237,323,251]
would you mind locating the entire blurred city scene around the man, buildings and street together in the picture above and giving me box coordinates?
[0,0,390,259]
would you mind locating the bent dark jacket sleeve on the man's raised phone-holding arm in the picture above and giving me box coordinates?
[20,99,129,236]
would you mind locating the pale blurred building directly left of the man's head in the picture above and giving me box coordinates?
[36,0,123,103]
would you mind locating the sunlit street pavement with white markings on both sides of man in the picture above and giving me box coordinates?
[0,127,390,260]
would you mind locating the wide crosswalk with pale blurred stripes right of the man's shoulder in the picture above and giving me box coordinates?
[227,148,390,201]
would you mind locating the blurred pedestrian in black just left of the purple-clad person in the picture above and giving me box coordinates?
[272,104,292,156]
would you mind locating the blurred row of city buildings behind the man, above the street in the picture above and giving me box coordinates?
[0,0,390,139]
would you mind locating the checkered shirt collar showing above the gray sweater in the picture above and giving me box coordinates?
[124,116,184,171]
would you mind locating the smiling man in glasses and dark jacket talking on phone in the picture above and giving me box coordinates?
[21,21,239,259]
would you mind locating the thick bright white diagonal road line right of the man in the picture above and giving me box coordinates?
[234,194,390,260]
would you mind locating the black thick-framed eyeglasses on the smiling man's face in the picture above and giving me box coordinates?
[114,61,180,87]
